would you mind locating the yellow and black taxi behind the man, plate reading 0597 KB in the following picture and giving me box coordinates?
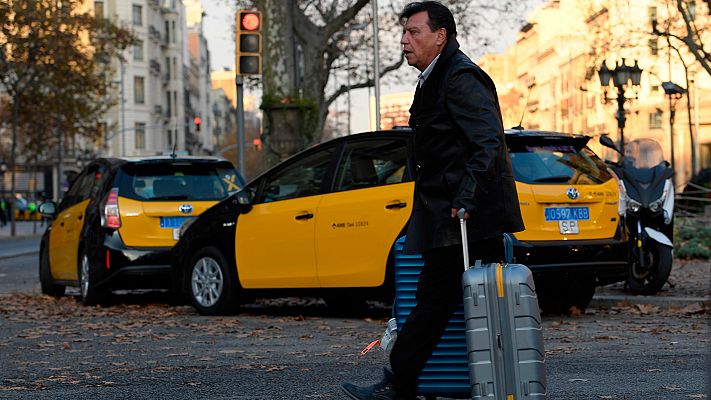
[173,130,626,314]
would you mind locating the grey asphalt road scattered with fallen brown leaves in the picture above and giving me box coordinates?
[0,255,711,400]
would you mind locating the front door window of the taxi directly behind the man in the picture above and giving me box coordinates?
[257,146,335,203]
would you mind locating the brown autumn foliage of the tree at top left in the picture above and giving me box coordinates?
[0,0,136,160]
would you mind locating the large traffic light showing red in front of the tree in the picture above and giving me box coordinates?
[235,10,262,75]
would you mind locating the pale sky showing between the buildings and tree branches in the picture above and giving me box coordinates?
[201,0,543,133]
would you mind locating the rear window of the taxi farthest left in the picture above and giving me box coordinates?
[119,161,244,201]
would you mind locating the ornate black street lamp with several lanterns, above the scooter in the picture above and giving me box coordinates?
[597,58,642,154]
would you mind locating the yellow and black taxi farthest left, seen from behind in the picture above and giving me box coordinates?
[39,155,244,305]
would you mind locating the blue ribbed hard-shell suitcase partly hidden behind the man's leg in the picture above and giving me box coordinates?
[395,237,471,399]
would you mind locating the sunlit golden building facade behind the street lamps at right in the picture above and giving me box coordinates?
[478,0,711,190]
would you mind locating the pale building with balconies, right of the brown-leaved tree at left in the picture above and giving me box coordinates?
[90,0,191,156]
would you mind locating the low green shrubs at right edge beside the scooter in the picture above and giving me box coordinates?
[674,218,711,259]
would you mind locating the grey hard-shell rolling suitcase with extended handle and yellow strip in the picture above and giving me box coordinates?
[458,210,547,400]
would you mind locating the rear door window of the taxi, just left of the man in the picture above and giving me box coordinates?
[335,139,410,191]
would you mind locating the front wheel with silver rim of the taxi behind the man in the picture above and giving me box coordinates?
[187,247,239,315]
